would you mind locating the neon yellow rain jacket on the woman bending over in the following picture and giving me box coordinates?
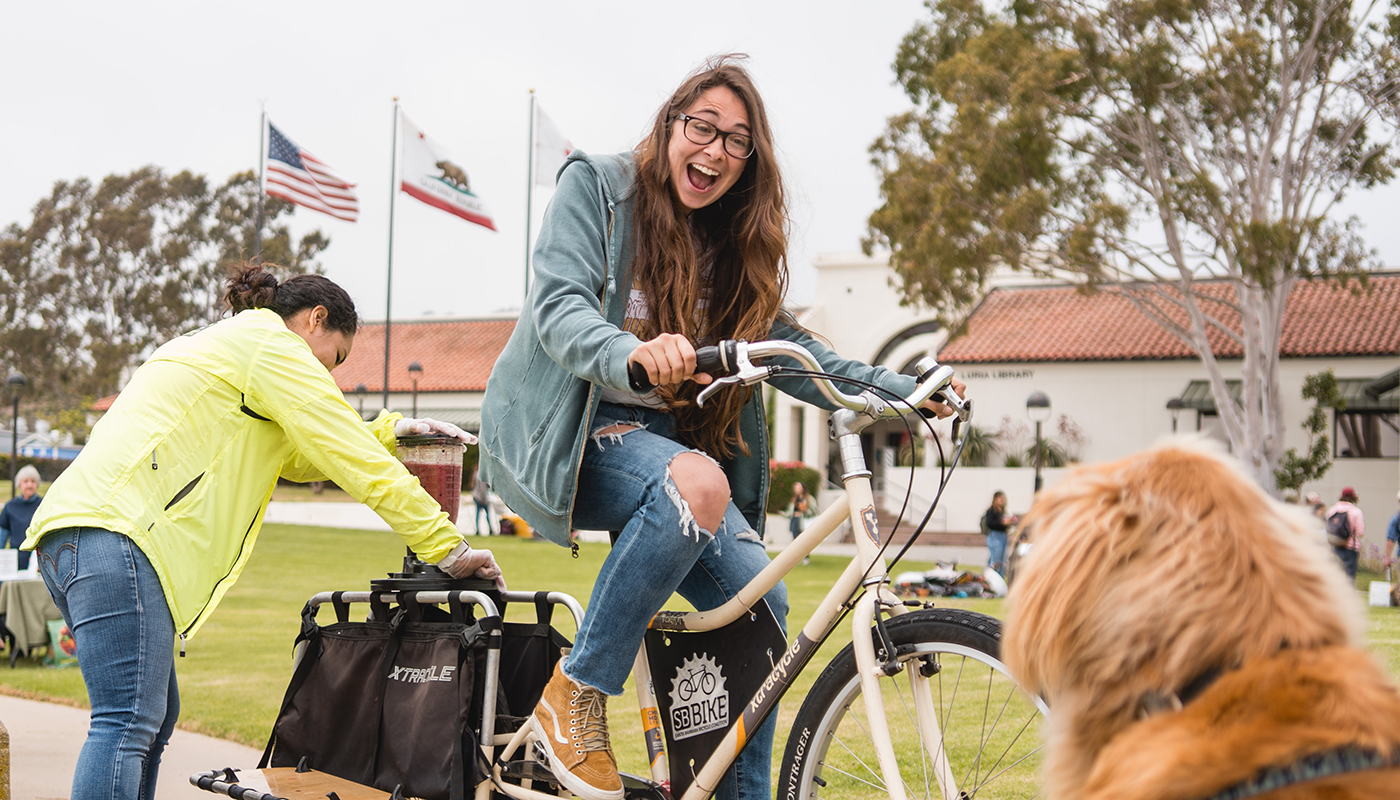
[22,308,462,637]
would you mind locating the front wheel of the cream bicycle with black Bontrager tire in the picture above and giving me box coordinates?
[778,608,1046,800]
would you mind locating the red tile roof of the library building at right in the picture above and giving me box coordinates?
[938,273,1400,364]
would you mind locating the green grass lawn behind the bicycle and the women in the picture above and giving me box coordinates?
[8,525,1400,790]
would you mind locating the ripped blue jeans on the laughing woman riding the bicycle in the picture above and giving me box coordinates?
[564,404,788,800]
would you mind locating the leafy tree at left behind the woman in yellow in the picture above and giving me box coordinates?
[0,167,329,411]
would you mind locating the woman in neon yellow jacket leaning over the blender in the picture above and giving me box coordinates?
[24,266,500,800]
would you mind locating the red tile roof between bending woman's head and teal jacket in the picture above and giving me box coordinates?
[330,319,515,394]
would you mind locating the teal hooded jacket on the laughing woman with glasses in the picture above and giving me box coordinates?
[480,150,914,545]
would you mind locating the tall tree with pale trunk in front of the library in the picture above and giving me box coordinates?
[864,0,1400,489]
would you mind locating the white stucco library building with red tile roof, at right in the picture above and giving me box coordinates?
[774,254,1400,546]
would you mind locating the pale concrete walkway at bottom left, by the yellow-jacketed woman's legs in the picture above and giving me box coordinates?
[0,695,262,800]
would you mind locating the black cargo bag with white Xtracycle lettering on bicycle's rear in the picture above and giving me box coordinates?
[259,593,500,800]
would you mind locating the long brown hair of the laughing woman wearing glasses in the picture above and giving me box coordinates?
[634,55,788,458]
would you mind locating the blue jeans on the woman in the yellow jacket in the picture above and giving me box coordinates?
[36,528,179,800]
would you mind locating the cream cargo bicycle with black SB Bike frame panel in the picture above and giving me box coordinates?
[190,340,1047,800]
